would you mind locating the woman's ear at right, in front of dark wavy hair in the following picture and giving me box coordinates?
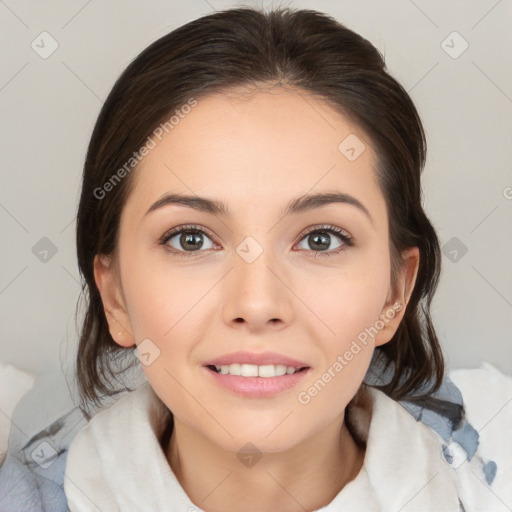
[375,247,420,347]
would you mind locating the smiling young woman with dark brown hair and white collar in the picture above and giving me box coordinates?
[64,8,505,512]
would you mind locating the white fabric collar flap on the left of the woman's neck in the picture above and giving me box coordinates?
[64,382,171,512]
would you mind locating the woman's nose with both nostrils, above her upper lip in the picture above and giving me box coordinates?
[222,243,293,333]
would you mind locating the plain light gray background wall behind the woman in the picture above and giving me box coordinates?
[0,0,512,384]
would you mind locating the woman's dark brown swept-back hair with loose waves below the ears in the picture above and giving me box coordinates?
[76,7,444,416]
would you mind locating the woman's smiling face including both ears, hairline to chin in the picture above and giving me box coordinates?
[95,88,417,452]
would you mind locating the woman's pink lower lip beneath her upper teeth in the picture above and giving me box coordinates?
[203,366,310,398]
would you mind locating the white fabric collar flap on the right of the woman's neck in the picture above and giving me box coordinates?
[347,387,459,512]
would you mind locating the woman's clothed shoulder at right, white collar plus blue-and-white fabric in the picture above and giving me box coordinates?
[347,364,512,512]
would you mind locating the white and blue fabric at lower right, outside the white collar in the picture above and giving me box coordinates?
[408,362,512,511]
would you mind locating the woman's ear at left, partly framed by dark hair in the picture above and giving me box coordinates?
[94,254,135,347]
